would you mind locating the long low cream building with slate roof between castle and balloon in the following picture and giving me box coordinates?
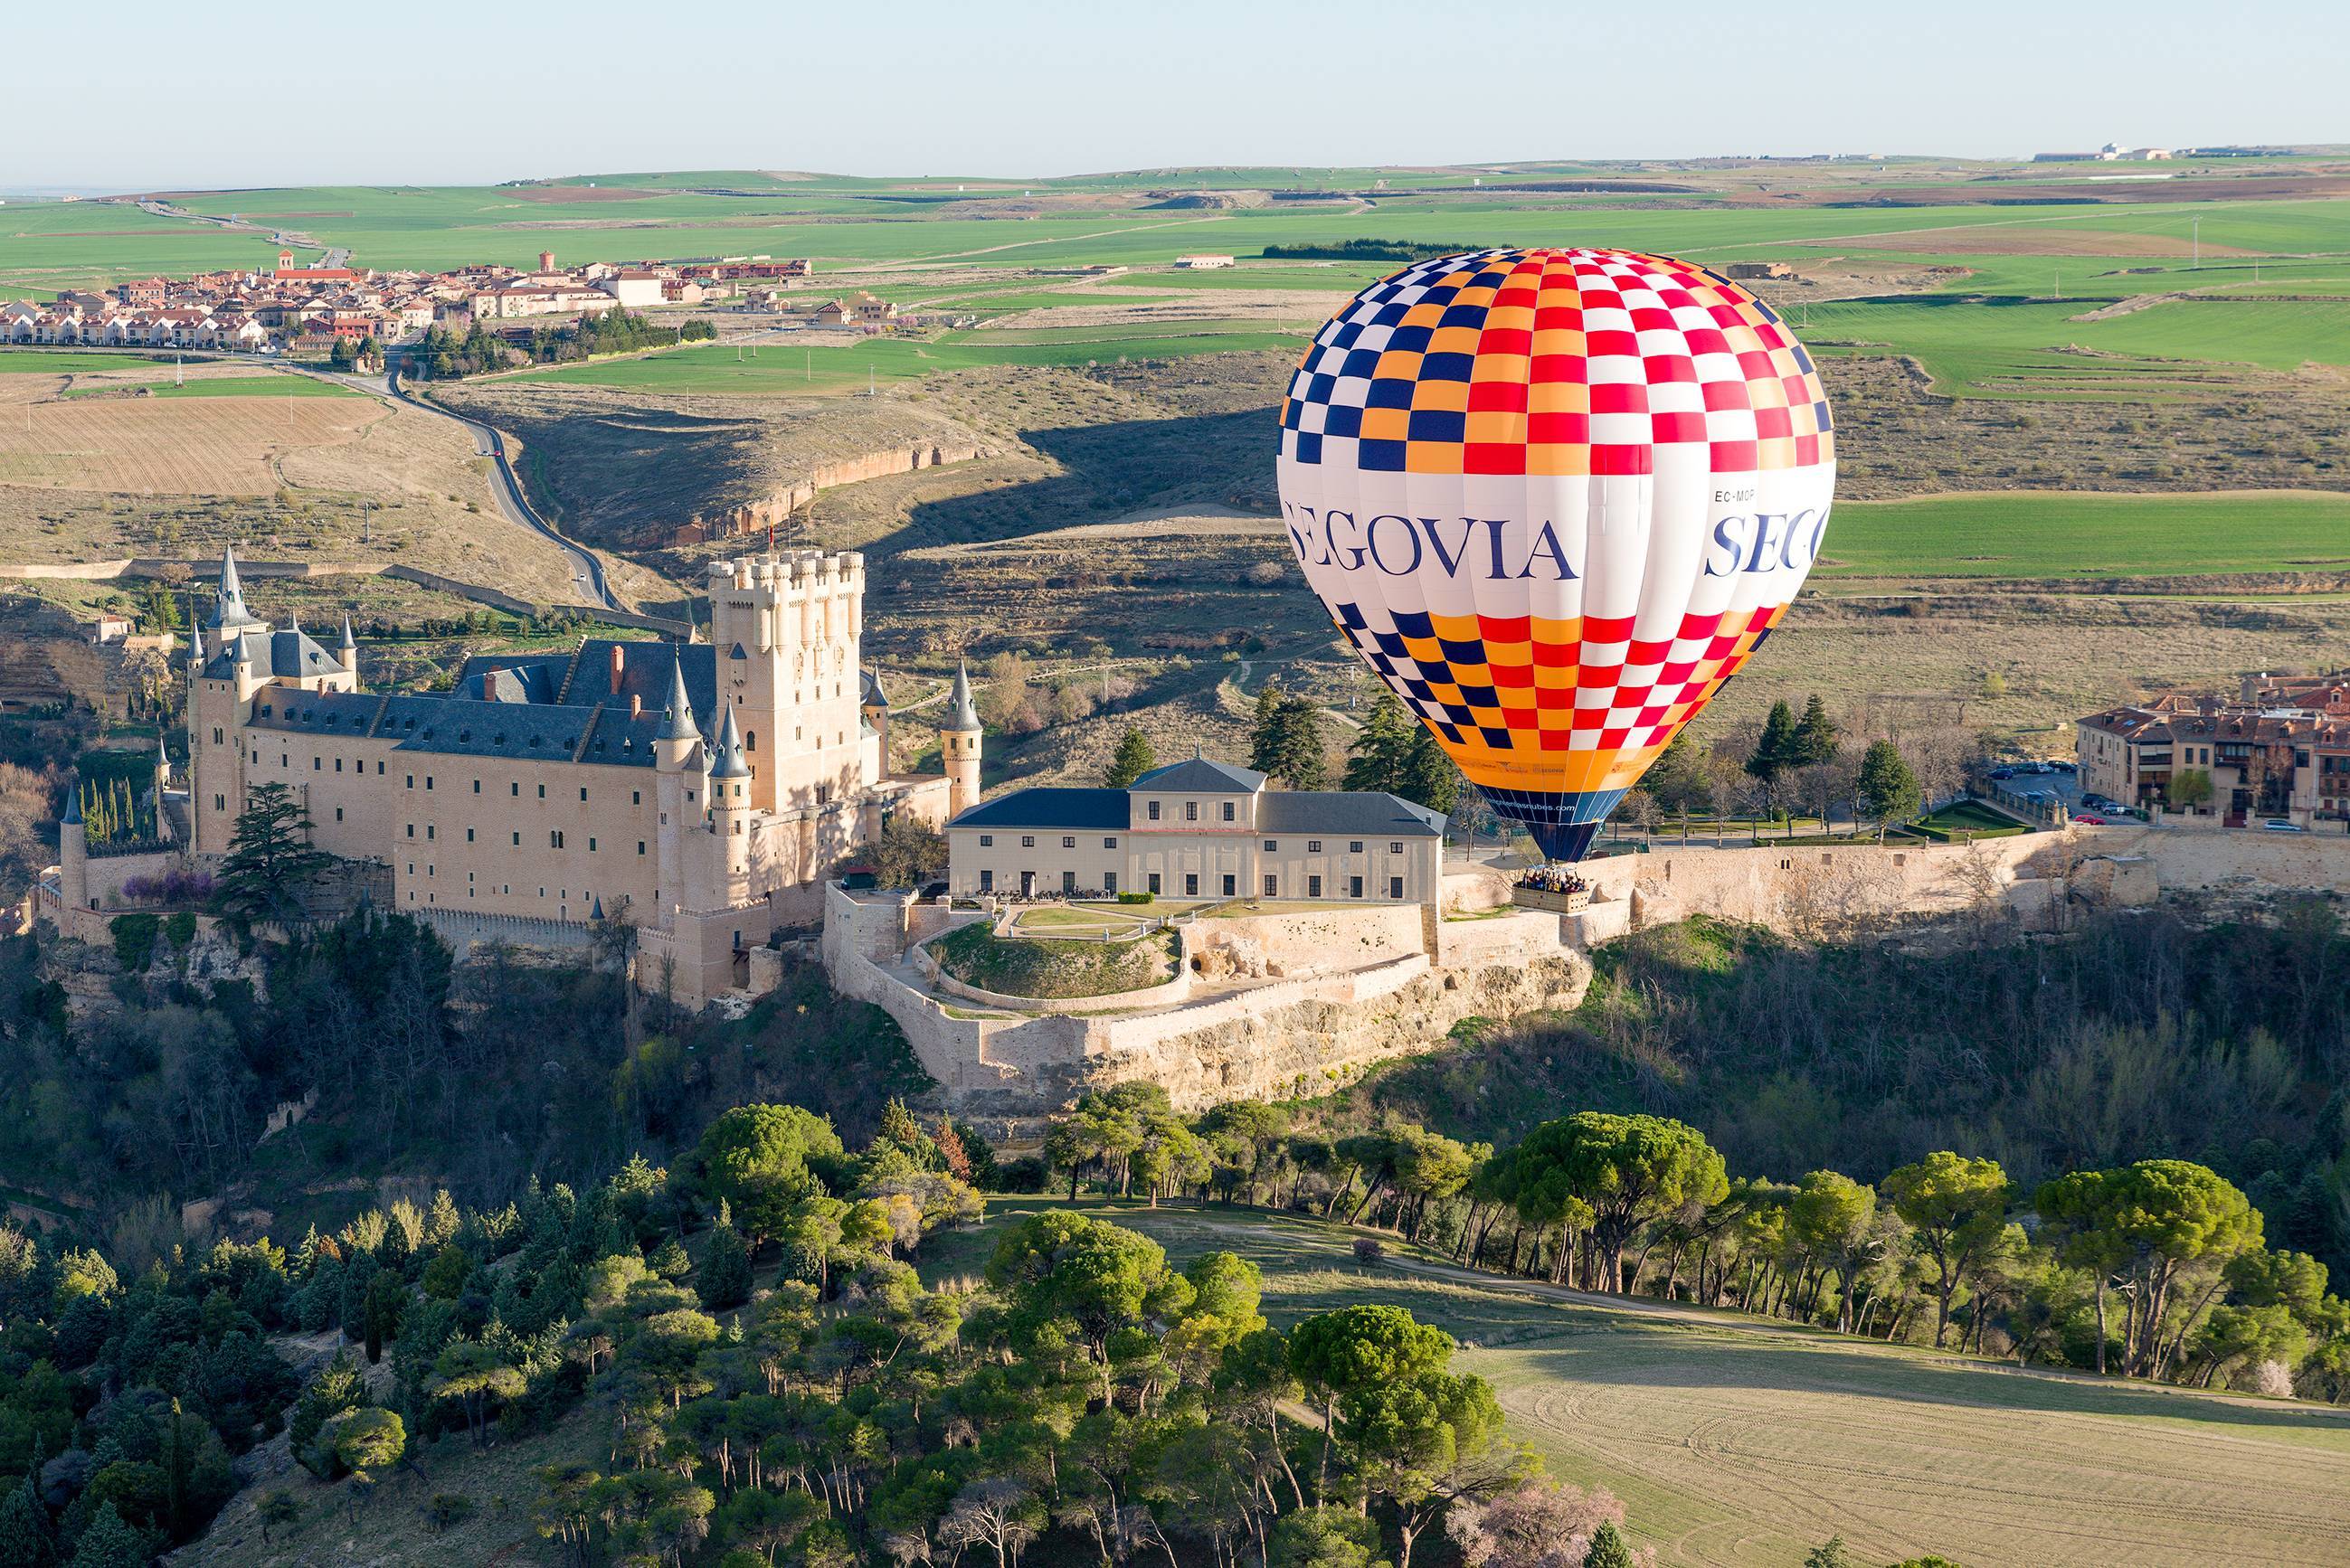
[943,761,1445,907]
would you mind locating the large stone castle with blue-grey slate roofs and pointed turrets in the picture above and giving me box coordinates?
[188,550,978,1001]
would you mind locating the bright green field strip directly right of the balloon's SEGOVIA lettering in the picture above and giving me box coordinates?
[1819,491,2350,579]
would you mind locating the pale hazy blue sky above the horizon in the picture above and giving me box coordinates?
[0,0,2350,191]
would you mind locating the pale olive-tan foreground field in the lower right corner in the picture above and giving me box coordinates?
[924,1196,2350,1568]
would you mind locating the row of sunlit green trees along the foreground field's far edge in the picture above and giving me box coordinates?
[1038,1083,2350,1401]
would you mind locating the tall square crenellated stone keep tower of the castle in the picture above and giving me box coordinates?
[710,550,865,811]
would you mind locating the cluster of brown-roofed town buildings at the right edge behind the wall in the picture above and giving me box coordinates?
[2075,673,2350,827]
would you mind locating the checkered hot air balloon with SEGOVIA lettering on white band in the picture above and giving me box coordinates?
[1281,250,1835,860]
